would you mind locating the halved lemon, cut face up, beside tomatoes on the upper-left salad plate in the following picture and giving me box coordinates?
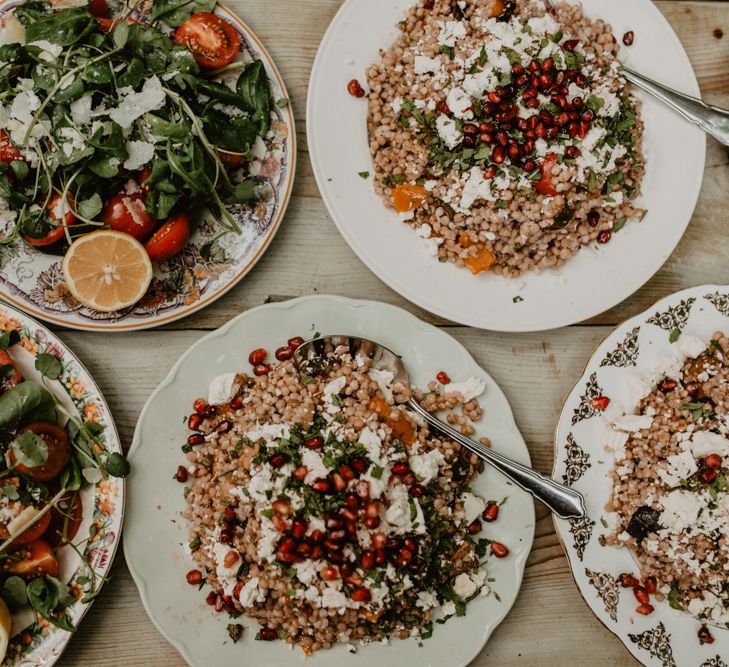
[63,230,152,313]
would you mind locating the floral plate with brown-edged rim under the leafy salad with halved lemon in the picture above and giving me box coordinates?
[0,0,296,331]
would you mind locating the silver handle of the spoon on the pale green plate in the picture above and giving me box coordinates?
[408,400,587,519]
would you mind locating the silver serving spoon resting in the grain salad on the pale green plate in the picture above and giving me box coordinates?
[294,336,586,519]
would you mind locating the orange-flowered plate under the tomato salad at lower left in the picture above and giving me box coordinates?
[0,304,124,667]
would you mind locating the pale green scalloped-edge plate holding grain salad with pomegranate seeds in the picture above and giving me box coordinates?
[124,296,534,667]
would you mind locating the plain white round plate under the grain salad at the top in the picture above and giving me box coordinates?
[307,0,706,331]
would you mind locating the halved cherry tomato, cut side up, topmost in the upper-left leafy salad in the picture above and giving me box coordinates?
[175,12,240,69]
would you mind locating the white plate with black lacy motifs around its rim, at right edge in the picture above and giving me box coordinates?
[554,285,729,667]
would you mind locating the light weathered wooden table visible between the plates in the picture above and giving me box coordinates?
[47,0,729,667]
